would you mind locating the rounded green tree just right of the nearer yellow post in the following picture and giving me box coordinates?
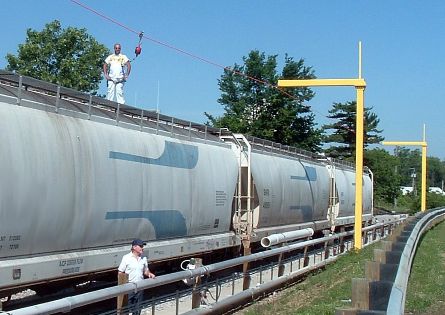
[365,149,401,203]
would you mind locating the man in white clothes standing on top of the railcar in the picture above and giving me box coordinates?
[103,43,131,104]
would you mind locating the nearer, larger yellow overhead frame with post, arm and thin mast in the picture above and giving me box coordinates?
[278,42,366,249]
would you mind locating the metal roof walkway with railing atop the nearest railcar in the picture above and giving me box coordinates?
[0,70,225,143]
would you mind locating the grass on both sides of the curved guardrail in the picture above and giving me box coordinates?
[237,222,445,315]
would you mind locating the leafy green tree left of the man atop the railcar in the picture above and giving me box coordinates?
[6,20,108,94]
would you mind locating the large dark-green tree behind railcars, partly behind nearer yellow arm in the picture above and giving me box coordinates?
[205,50,322,151]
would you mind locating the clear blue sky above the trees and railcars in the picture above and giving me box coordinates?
[0,0,445,159]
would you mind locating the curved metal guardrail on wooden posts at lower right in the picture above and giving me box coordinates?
[336,208,445,315]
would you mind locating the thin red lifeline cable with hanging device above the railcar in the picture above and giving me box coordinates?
[70,0,296,99]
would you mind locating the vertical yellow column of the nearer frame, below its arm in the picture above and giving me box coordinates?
[354,87,365,249]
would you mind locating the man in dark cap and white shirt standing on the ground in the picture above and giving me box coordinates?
[118,239,155,315]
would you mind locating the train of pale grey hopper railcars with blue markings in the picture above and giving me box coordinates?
[0,71,372,296]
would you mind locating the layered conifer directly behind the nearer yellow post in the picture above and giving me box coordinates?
[323,101,384,160]
